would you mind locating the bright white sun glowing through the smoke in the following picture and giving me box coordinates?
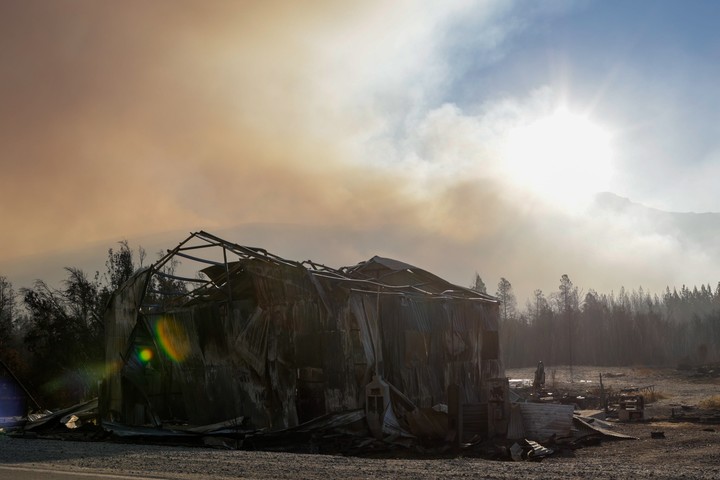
[503,107,613,204]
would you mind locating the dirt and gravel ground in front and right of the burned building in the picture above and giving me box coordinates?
[0,366,720,480]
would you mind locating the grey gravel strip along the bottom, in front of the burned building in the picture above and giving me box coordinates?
[0,424,720,480]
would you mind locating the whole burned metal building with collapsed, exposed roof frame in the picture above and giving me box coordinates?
[100,232,504,438]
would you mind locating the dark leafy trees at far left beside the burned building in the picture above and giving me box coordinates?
[0,241,145,408]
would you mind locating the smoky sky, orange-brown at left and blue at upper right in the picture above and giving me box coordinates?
[0,0,720,304]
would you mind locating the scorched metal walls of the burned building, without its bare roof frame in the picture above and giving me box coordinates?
[104,246,499,430]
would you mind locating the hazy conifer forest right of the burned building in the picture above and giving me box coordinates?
[471,274,720,367]
